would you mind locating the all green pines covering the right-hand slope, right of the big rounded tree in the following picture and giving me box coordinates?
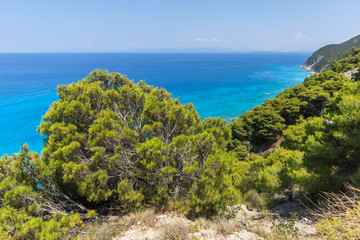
[229,49,360,199]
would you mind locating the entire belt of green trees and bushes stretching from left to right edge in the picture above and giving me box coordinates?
[0,49,360,239]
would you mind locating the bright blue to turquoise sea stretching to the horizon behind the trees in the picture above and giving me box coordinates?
[0,53,309,155]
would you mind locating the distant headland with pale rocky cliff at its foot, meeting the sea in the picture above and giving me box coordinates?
[302,35,360,73]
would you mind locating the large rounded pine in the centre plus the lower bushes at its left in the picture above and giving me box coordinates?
[0,70,249,239]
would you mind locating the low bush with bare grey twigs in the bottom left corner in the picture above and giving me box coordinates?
[0,145,86,239]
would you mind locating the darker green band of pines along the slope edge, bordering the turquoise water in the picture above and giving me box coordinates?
[230,70,350,151]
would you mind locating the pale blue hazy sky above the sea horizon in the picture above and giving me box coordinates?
[0,0,360,52]
